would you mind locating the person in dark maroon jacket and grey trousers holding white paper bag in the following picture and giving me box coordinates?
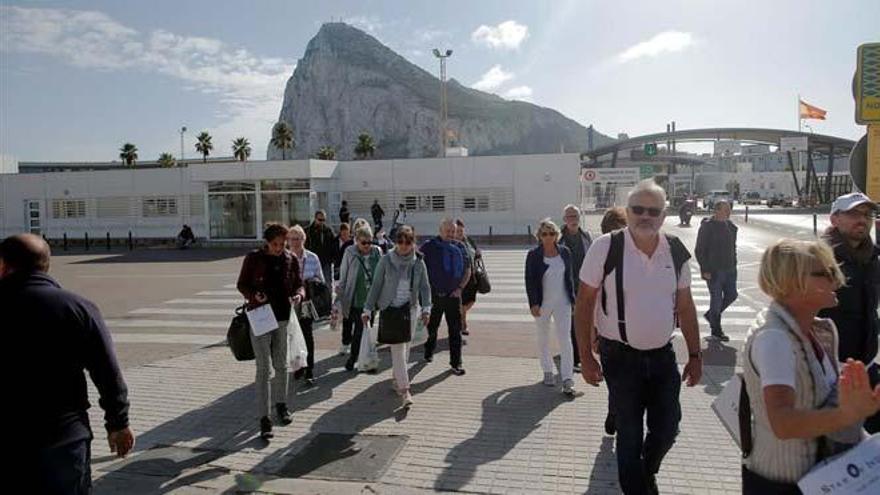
[236,223,305,440]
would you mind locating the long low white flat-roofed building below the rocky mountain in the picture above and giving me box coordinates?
[0,153,580,241]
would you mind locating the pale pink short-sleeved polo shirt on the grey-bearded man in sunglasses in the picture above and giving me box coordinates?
[580,228,691,350]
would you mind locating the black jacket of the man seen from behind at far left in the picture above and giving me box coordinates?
[0,273,129,449]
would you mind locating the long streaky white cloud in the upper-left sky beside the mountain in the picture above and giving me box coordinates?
[0,6,295,156]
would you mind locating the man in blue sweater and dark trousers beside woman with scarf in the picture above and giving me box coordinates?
[421,218,471,376]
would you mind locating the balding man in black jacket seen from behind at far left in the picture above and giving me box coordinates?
[0,234,134,494]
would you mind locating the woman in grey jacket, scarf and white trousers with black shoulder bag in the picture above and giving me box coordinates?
[361,225,431,407]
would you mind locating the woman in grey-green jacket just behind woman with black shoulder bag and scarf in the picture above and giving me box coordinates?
[331,223,382,371]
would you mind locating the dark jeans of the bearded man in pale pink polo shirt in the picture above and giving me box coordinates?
[599,338,681,495]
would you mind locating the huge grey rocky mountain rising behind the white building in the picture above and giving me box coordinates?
[268,23,611,160]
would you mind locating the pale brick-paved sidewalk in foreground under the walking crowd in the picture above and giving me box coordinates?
[90,342,740,494]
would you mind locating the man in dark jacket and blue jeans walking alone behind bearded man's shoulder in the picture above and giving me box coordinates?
[694,199,737,342]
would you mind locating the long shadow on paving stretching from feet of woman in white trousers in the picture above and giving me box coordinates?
[434,383,569,491]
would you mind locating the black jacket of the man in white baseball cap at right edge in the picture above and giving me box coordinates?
[819,238,880,365]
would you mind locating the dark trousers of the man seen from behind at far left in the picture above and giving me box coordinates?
[37,439,92,495]
